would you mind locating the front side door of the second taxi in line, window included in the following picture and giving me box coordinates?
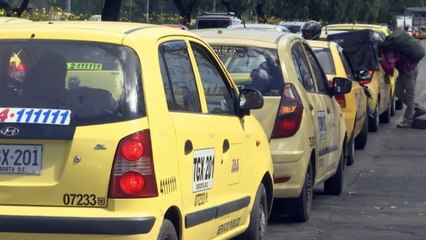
[304,44,342,176]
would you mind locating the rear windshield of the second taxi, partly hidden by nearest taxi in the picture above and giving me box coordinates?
[212,45,284,96]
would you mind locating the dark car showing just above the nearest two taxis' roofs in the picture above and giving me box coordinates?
[195,12,244,29]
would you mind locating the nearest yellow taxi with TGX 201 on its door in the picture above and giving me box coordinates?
[0,21,273,240]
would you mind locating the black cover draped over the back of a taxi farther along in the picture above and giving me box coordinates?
[327,29,384,72]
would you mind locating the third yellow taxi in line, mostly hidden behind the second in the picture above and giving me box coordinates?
[308,40,368,165]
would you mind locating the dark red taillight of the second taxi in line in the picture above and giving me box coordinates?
[271,83,303,138]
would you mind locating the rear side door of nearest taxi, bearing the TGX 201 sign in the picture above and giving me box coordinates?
[159,39,221,238]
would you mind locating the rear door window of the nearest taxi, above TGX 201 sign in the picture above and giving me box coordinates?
[159,41,201,112]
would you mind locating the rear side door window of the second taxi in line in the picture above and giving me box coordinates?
[291,43,315,92]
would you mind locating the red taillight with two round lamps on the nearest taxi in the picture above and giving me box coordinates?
[108,130,158,198]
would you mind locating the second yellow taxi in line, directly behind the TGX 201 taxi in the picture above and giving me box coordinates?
[194,29,351,221]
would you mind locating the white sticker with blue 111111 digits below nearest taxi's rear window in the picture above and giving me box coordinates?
[0,108,71,125]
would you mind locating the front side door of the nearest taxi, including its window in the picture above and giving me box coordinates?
[186,40,251,235]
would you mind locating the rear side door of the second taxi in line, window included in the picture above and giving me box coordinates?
[292,42,328,181]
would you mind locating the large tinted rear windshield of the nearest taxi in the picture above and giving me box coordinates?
[0,40,145,126]
